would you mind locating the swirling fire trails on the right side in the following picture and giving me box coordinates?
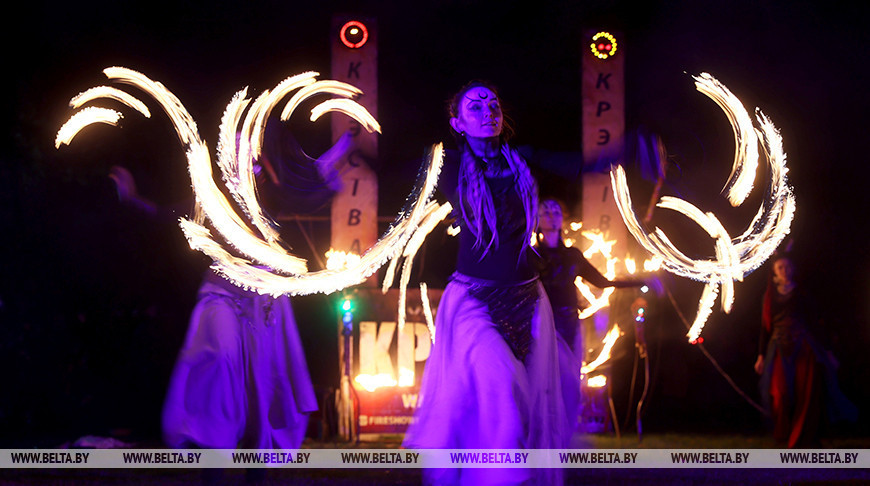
[610,73,795,341]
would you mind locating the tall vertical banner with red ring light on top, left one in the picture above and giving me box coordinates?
[331,16,378,270]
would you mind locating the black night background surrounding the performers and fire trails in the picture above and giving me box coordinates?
[0,1,870,447]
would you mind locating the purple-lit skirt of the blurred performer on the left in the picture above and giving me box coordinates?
[163,278,317,449]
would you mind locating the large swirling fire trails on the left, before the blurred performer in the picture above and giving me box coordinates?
[55,67,442,295]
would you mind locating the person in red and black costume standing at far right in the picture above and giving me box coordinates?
[755,255,857,448]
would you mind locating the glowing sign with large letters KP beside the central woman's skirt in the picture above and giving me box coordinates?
[352,288,443,434]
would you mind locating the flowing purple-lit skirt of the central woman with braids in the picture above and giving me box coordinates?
[404,281,570,486]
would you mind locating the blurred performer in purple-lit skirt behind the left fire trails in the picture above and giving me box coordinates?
[110,124,352,468]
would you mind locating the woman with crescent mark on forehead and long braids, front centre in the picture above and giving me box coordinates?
[405,82,566,484]
